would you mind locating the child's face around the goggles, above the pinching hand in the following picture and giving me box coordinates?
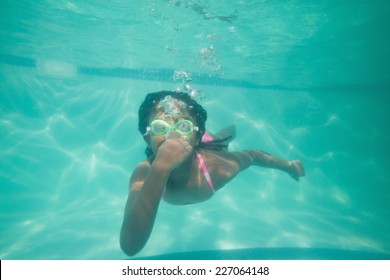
[144,100,197,155]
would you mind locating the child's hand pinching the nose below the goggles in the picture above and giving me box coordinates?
[156,136,193,170]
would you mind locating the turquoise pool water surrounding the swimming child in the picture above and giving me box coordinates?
[0,0,390,259]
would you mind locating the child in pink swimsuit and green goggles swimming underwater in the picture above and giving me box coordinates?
[120,91,305,256]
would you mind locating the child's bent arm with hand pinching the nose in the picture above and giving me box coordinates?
[120,138,192,256]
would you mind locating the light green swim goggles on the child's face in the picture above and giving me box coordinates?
[144,119,199,136]
